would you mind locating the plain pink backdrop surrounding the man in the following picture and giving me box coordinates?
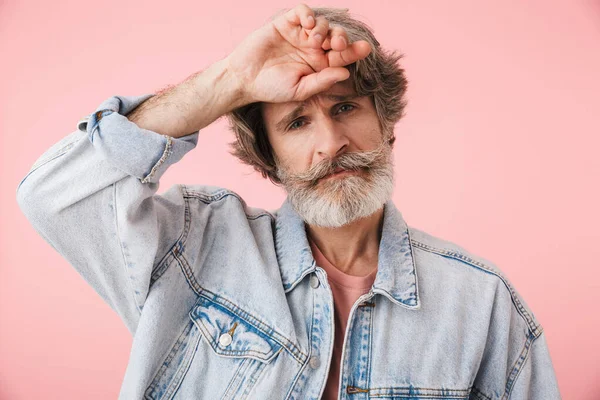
[0,0,600,400]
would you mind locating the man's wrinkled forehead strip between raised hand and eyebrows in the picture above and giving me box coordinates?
[262,78,356,124]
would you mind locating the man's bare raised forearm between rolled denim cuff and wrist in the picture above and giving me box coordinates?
[127,59,249,138]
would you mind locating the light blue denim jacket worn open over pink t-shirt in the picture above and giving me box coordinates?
[17,95,560,400]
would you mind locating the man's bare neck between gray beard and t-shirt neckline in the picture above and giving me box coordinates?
[306,207,383,276]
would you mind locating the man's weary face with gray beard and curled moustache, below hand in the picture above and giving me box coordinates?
[262,79,393,228]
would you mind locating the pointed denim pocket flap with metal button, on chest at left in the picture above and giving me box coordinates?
[190,297,281,363]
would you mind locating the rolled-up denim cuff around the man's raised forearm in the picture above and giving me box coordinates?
[77,94,198,183]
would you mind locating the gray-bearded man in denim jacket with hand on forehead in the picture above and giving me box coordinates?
[17,4,560,400]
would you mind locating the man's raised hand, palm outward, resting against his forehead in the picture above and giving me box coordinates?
[226,4,371,103]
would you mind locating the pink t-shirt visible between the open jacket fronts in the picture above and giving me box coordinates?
[308,239,377,400]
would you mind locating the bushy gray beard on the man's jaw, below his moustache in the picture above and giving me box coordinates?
[282,145,394,228]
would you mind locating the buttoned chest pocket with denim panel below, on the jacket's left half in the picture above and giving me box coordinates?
[144,297,282,400]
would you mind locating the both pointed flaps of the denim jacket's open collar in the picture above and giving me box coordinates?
[275,199,421,309]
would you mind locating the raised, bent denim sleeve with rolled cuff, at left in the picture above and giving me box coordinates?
[17,94,198,333]
